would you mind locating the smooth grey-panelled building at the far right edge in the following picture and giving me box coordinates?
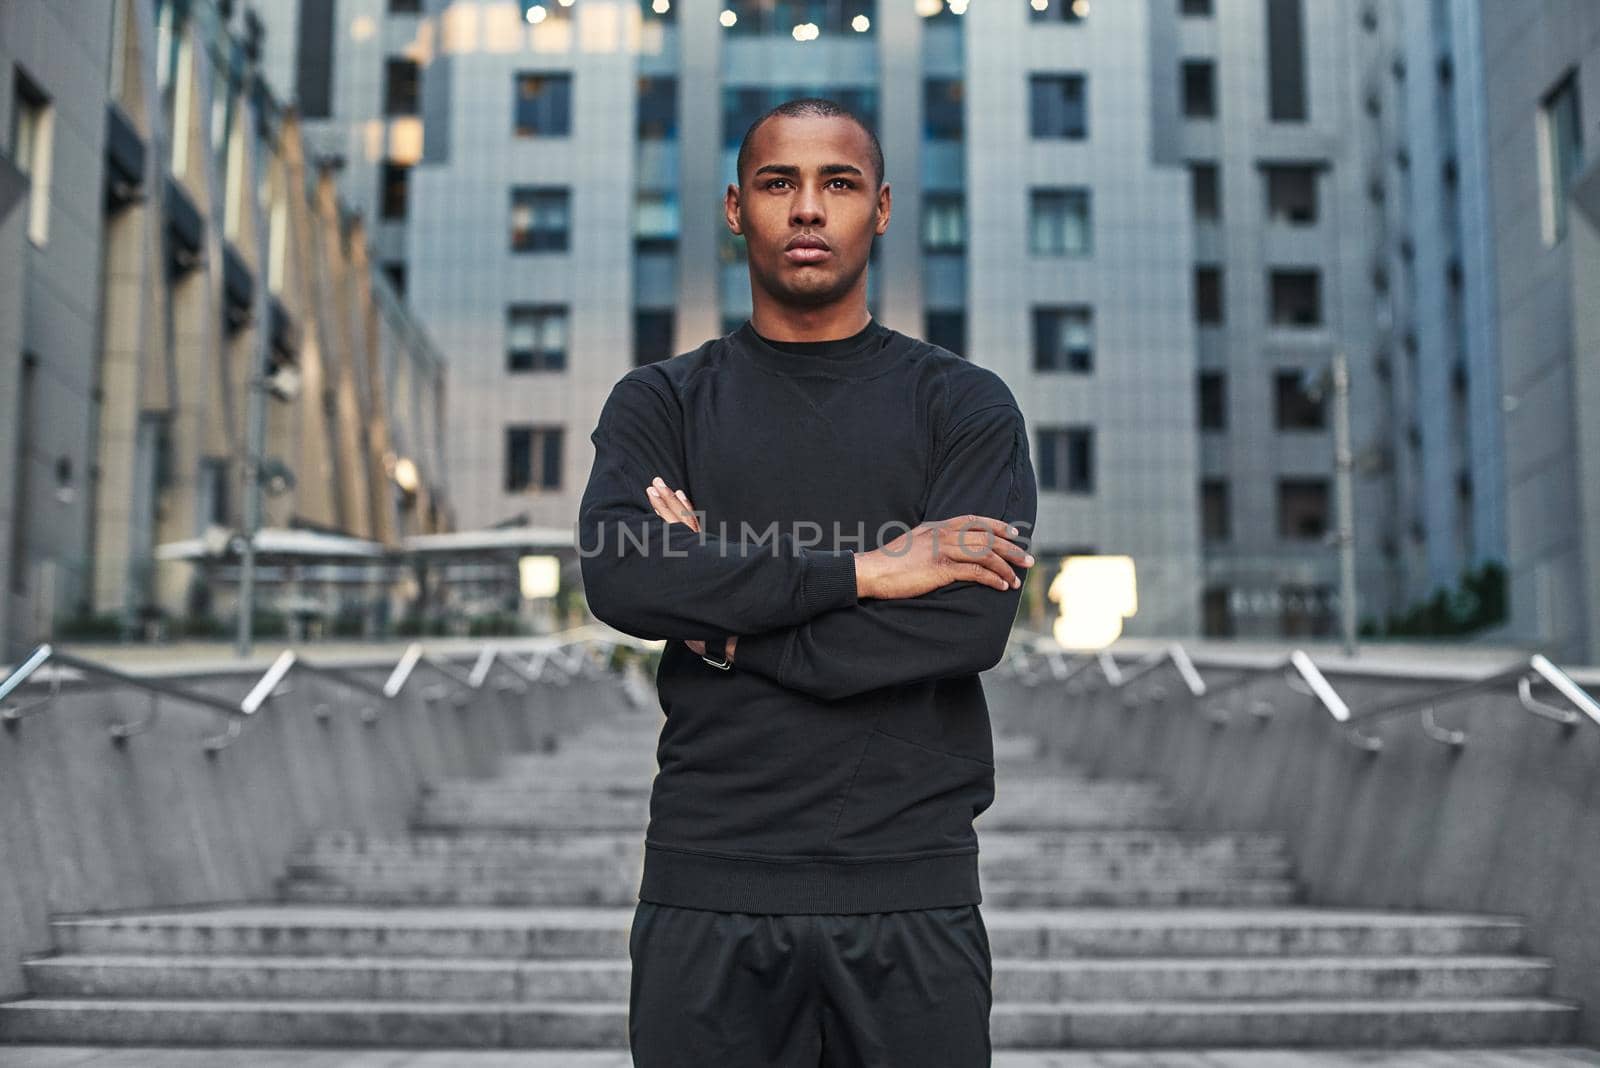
[1458,3,1600,664]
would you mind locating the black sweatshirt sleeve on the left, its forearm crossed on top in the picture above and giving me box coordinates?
[578,377,856,641]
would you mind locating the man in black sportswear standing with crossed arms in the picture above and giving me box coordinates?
[579,98,1037,1068]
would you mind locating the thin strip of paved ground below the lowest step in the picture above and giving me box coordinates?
[0,1046,1600,1068]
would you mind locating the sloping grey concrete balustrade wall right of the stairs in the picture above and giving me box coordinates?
[986,644,1600,1046]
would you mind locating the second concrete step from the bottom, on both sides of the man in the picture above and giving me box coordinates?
[22,954,1552,1002]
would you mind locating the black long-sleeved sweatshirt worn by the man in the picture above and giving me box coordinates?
[578,320,1037,913]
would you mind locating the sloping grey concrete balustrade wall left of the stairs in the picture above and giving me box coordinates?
[0,640,630,1001]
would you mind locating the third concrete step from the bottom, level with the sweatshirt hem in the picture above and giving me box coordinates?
[51,903,1523,959]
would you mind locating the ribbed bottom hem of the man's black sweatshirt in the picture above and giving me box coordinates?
[638,843,982,913]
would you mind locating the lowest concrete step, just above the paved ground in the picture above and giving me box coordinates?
[0,998,1579,1049]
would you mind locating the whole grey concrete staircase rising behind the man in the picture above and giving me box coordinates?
[0,716,1578,1050]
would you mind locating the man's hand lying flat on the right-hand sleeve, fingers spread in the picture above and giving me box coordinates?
[856,515,1034,600]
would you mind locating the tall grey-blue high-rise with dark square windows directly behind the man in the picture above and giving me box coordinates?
[193,0,1595,652]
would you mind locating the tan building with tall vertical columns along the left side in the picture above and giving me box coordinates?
[0,0,451,662]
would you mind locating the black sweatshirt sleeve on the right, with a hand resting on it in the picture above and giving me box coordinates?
[733,391,1038,700]
